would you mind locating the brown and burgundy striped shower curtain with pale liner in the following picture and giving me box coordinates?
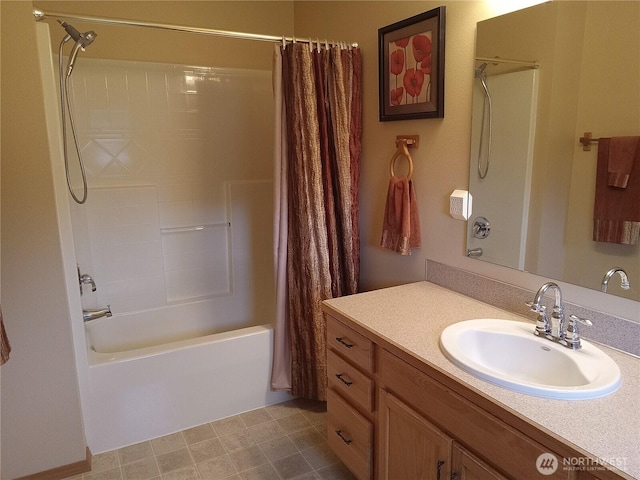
[272,43,362,400]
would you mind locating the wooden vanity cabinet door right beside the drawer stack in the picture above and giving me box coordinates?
[378,390,453,480]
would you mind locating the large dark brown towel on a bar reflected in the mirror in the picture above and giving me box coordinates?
[593,137,640,245]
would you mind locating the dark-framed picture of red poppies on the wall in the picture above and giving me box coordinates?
[378,6,446,122]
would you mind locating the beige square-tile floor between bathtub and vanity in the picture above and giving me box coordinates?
[67,399,354,480]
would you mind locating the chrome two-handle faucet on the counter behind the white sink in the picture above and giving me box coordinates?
[527,282,593,350]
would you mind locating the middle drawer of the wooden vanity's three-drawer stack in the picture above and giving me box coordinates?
[327,350,374,412]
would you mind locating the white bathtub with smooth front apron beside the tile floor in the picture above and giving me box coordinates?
[83,301,290,454]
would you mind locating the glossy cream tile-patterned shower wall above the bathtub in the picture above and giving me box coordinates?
[70,59,273,316]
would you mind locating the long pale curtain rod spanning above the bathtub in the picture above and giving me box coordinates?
[33,9,358,48]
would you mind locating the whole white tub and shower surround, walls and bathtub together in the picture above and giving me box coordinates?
[37,25,289,454]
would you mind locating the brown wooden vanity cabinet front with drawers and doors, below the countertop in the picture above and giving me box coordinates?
[325,310,626,480]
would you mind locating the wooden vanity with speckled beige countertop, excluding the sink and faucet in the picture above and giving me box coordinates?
[323,282,640,480]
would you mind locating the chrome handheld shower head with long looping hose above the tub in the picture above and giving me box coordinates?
[58,20,98,204]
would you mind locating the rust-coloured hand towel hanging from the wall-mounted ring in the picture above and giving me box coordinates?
[380,176,420,255]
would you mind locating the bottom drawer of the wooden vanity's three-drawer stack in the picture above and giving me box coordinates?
[327,390,373,479]
